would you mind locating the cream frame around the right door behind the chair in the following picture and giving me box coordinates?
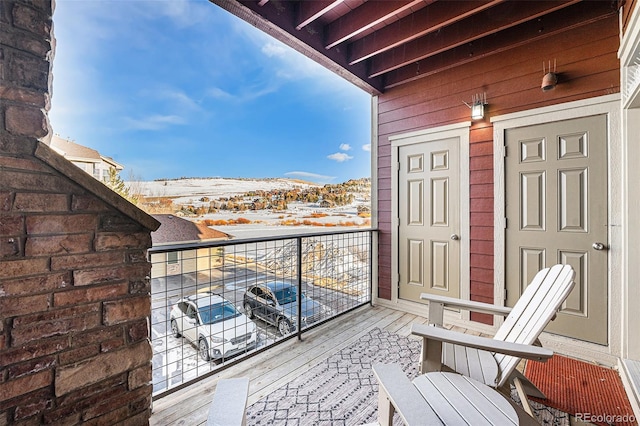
[491,94,622,365]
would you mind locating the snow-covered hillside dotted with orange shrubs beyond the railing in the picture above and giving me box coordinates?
[128,177,371,238]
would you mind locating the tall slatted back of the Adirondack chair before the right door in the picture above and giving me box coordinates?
[494,265,575,386]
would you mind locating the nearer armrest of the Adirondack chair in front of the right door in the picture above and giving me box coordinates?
[411,324,553,361]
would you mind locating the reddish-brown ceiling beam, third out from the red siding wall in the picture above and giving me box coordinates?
[349,0,505,65]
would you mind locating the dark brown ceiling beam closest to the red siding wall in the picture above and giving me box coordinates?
[384,2,617,89]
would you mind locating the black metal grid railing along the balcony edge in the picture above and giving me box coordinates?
[149,230,374,398]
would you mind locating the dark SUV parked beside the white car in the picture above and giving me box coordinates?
[244,281,330,336]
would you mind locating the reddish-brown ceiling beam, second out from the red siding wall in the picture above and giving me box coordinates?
[369,0,580,77]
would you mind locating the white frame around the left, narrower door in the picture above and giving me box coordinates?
[389,121,471,319]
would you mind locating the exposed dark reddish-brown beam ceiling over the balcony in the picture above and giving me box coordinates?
[210,0,616,93]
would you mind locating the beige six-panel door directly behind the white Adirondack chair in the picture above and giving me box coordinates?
[505,115,608,344]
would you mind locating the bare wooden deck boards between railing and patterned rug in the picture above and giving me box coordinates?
[150,306,426,426]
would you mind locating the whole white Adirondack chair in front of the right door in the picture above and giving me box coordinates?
[411,265,575,414]
